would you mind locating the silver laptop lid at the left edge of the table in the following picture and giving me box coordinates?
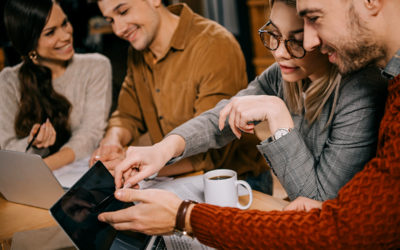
[0,150,65,209]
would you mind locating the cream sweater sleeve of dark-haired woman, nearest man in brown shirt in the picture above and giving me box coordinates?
[63,56,111,160]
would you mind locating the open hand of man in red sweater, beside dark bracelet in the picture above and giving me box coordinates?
[98,189,182,235]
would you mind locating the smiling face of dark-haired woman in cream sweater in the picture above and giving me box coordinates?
[36,4,74,62]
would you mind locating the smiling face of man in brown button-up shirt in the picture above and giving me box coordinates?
[98,0,160,50]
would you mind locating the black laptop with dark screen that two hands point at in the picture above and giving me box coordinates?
[50,161,151,249]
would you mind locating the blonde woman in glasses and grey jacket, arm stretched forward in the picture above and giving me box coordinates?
[109,1,385,201]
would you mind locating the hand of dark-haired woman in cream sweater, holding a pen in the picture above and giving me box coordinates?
[28,118,57,148]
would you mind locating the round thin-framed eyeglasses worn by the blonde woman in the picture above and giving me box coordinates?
[258,21,306,59]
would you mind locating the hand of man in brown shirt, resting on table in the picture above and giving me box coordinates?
[89,141,125,175]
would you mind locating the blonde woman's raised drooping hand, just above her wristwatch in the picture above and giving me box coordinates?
[219,95,294,138]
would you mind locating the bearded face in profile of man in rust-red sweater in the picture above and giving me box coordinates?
[297,0,385,74]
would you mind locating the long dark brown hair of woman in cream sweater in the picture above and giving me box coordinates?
[4,0,71,153]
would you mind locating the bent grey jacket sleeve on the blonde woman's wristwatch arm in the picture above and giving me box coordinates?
[258,67,385,200]
